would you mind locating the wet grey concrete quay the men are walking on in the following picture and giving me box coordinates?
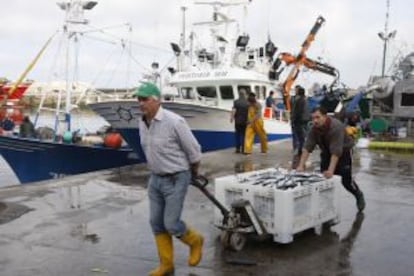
[0,142,414,276]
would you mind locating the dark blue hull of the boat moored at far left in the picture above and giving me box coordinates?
[0,136,143,184]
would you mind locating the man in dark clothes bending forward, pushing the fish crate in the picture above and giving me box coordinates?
[296,107,365,212]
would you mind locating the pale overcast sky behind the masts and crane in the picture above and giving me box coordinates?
[0,0,414,88]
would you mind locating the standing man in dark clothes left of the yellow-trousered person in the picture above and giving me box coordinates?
[230,88,249,153]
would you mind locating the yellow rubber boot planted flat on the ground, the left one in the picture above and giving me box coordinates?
[148,233,174,276]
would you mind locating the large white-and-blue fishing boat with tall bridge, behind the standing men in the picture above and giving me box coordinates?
[89,1,291,154]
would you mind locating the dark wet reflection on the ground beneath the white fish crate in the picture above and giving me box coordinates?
[215,213,364,275]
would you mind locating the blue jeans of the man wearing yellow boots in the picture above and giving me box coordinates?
[148,171,191,237]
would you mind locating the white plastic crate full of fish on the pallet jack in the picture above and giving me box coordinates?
[214,168,342,243]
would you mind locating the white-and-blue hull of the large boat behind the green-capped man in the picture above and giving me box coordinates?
[89,100,291,156]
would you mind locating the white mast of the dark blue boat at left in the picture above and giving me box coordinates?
[56,0,98,131]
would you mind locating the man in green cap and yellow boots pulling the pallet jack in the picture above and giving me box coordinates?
[134,82,203,276]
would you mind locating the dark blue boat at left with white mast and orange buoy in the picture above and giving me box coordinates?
[0,0,142,184]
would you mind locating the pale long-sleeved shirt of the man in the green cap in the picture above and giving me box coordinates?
[139,106,201,174]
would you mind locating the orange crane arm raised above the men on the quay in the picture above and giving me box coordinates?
[274,16,338,111]
